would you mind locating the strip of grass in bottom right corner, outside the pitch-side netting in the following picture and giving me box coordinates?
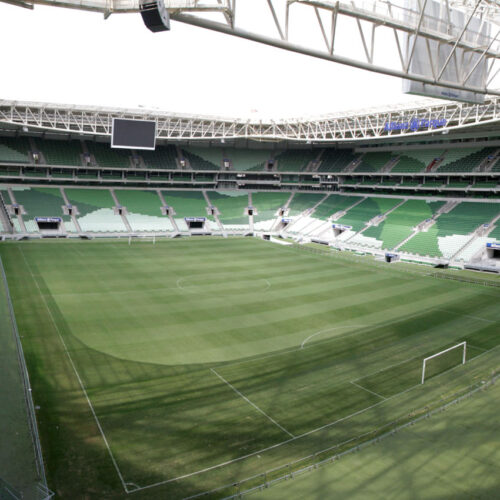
[251,376,500,500]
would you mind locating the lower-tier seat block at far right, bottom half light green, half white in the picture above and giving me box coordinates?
[400,202,500,258]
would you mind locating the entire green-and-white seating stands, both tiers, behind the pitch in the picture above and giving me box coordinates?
[0,131,500,272]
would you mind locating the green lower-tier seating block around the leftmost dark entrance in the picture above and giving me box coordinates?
[12,187,65,233]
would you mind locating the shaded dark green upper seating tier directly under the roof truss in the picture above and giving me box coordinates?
[0,137,500,174]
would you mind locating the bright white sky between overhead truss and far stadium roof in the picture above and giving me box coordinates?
[0,4,430,119]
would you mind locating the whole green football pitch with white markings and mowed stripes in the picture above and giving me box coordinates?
[0,238,500,499]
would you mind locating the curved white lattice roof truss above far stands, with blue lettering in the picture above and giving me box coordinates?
[0,98,500,144]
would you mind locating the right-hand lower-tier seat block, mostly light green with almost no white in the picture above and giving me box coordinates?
[360,200,444,250]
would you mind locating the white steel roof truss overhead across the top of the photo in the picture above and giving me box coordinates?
[0,0,500,98]
